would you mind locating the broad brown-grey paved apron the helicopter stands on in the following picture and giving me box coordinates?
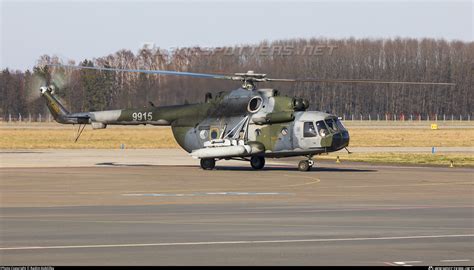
[0,150,474,265]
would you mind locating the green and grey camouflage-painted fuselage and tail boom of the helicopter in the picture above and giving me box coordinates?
[41,87,349,158]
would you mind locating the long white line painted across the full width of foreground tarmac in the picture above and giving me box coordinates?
[0,234,474,251]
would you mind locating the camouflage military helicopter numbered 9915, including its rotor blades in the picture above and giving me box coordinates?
[40,64,453,171]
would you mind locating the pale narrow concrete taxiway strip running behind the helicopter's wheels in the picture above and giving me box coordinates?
[0,147,474,168]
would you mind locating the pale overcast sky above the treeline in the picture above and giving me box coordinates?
[0,0,474,70]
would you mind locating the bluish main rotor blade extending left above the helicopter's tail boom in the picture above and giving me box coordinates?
[48,64,234,80]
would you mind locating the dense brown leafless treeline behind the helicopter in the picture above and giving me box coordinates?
[0,38,474,117]
